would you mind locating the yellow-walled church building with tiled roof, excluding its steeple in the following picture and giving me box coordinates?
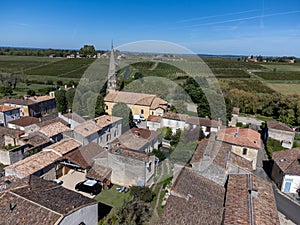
[104,91,168,118]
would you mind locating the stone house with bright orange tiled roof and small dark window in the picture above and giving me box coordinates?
[216,127,262,170]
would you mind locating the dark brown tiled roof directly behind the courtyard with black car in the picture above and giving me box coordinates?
[59,142,105,169]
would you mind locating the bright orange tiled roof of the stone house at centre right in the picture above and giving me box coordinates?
[216,127,261,149]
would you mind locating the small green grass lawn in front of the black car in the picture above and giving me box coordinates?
[94,185,130,208]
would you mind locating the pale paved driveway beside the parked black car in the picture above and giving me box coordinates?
[59,170,93,198]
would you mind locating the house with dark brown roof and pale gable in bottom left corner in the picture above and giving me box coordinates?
[0,176,98,225]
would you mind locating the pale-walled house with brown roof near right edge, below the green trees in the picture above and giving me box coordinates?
[267,121,295,149]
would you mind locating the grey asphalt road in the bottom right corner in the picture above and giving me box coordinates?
[273,185,300,224]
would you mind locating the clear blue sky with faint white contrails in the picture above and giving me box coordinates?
[0,0,300,57]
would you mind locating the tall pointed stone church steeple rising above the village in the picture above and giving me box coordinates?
[107,41,118,92]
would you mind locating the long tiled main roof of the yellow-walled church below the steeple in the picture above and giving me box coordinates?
[104,91,156,107]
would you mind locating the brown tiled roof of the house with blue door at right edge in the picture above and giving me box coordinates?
[272,148,300,176]
